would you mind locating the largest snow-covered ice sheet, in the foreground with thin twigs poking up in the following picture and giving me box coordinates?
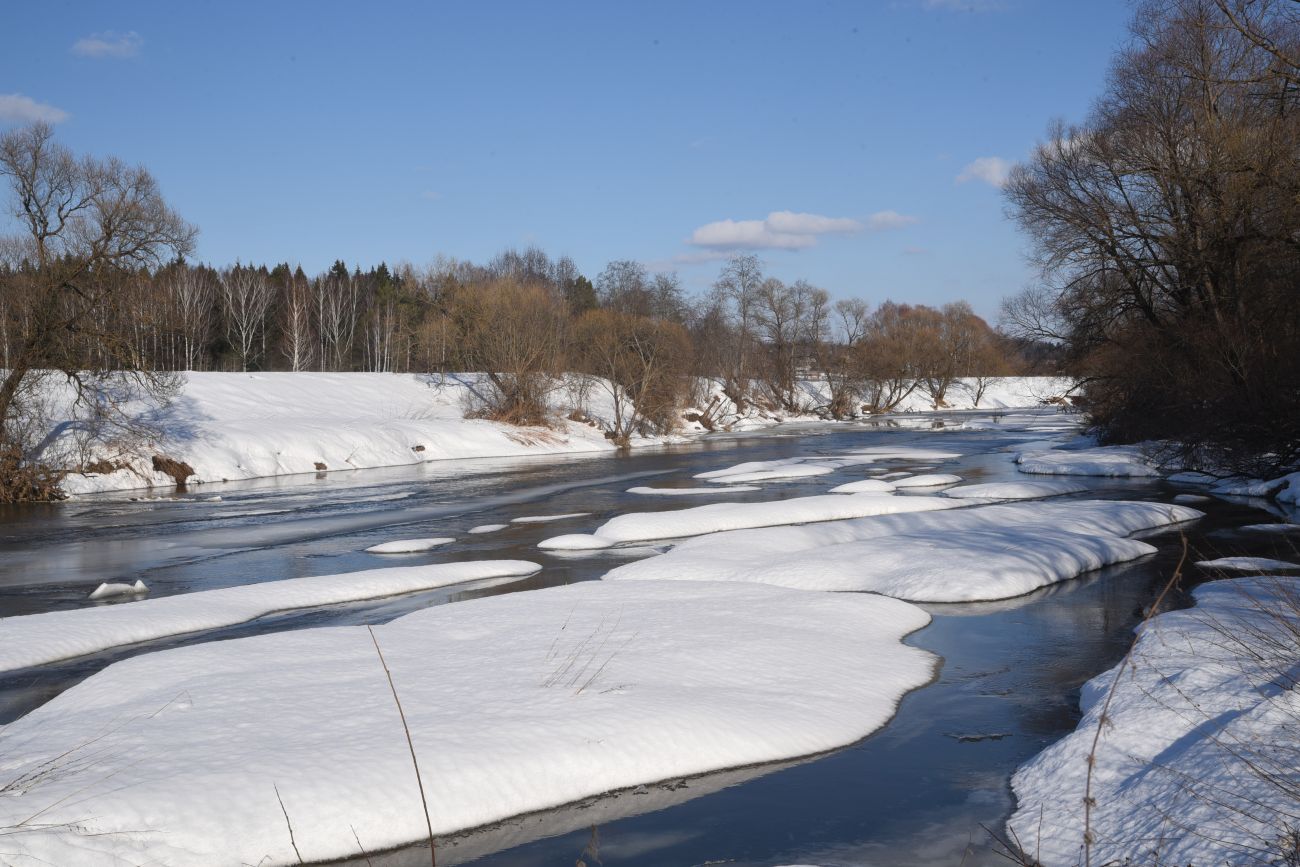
[0,582,936,867]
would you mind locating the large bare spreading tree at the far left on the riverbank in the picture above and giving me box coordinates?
[0,123,196,499]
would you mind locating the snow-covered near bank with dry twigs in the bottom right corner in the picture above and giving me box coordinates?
[1009,577,1300,867]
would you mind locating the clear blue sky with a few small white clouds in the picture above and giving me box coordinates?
[0,0,1130,316]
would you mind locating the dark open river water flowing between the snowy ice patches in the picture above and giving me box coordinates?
[0,412,1297,866]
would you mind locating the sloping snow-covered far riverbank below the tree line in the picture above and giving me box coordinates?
[47,373,1070,494]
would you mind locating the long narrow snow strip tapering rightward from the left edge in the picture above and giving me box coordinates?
[0,560,542,671]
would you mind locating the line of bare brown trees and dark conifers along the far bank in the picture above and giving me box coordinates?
[0,123,1044,501]
